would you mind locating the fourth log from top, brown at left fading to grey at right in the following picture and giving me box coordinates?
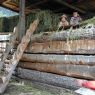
[19,62,95,79]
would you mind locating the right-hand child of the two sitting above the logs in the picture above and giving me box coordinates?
[70,12,82,29]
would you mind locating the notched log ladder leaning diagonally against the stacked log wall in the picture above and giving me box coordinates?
[0,20,38,93]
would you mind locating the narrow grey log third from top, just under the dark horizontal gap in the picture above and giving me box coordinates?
[21,54,95,65]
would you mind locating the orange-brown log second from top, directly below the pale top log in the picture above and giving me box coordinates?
[26,39,95,54]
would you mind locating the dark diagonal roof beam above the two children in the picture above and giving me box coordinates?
[55,0,86,13]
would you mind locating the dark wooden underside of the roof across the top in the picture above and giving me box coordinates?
[0,0,95,14]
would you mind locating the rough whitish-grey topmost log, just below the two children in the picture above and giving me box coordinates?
[31,28,95,43]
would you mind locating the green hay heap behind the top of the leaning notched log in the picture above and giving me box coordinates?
[26,11,59,33]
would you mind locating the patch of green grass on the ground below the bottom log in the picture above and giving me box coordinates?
[4,82,54,95]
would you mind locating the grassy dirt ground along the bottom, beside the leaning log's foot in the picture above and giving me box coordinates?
[2,80,74,95]
